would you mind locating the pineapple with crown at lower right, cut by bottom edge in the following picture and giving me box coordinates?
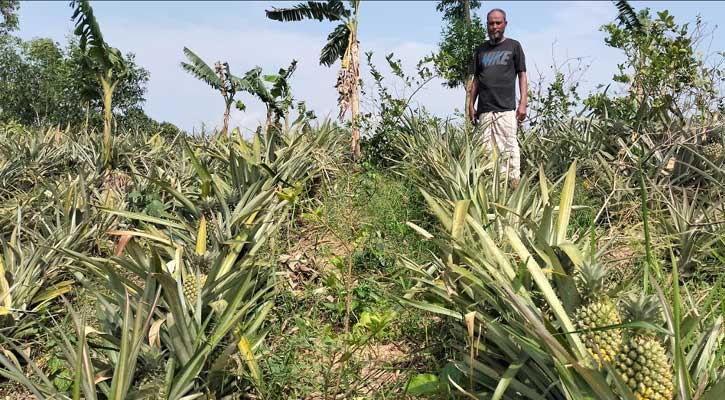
[615,296,673,400]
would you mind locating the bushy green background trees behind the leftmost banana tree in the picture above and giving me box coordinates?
[0,36,149,127]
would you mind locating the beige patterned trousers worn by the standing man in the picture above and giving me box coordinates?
[479,111,521,180]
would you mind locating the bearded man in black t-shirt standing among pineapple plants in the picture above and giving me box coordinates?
[468,8,528,186]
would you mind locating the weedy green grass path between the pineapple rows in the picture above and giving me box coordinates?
[255,164,449,399]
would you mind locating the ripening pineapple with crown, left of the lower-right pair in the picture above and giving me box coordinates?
[574,262,622,366]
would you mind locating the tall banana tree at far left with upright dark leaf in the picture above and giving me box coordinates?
[70,0,128,167]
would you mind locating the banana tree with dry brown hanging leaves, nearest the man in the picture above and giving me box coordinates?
[265,0,360,159]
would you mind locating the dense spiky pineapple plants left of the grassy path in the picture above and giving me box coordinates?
[0,118,343,399]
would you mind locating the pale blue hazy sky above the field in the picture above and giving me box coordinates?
[16,0,725,134]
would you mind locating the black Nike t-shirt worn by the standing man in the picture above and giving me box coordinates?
[473,38,526,114]
